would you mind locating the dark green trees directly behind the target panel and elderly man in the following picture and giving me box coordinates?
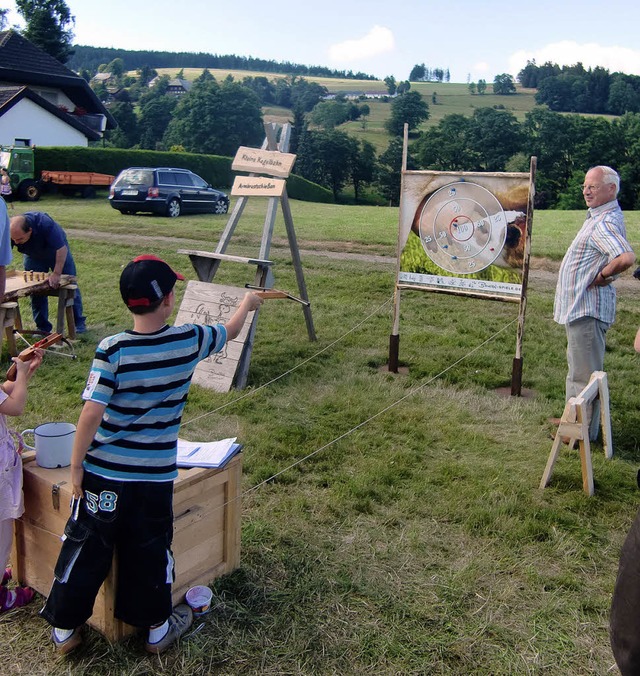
[409,106,640,209]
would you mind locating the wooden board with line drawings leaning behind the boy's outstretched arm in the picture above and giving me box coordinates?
[175,281,255,392]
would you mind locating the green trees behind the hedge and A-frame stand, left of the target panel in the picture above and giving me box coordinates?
[101,68,429,203]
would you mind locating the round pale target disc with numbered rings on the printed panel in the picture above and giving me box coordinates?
[418,181,507,275]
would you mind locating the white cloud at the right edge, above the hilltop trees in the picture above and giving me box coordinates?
[509,40,640,75]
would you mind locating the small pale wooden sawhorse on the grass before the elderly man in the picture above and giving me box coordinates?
[540,371,613,495]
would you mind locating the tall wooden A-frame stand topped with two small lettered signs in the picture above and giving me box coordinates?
[178,123,316,391]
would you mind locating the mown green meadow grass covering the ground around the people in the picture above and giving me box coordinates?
[0,198,640,675]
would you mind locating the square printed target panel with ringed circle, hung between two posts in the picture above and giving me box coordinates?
[397,171,530,300]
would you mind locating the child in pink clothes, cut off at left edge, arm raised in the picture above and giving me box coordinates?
[0,350,42,613]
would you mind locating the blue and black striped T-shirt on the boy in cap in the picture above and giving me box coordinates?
[82,324,227,481]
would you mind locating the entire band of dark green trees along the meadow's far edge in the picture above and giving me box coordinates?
[107,62,640,209]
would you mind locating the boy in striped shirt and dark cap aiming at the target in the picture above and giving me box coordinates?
[41,255,262,654]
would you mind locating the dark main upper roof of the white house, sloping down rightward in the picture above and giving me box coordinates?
[0,30,117,129]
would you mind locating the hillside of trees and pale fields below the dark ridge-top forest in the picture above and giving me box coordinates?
[79,50,640,209]
